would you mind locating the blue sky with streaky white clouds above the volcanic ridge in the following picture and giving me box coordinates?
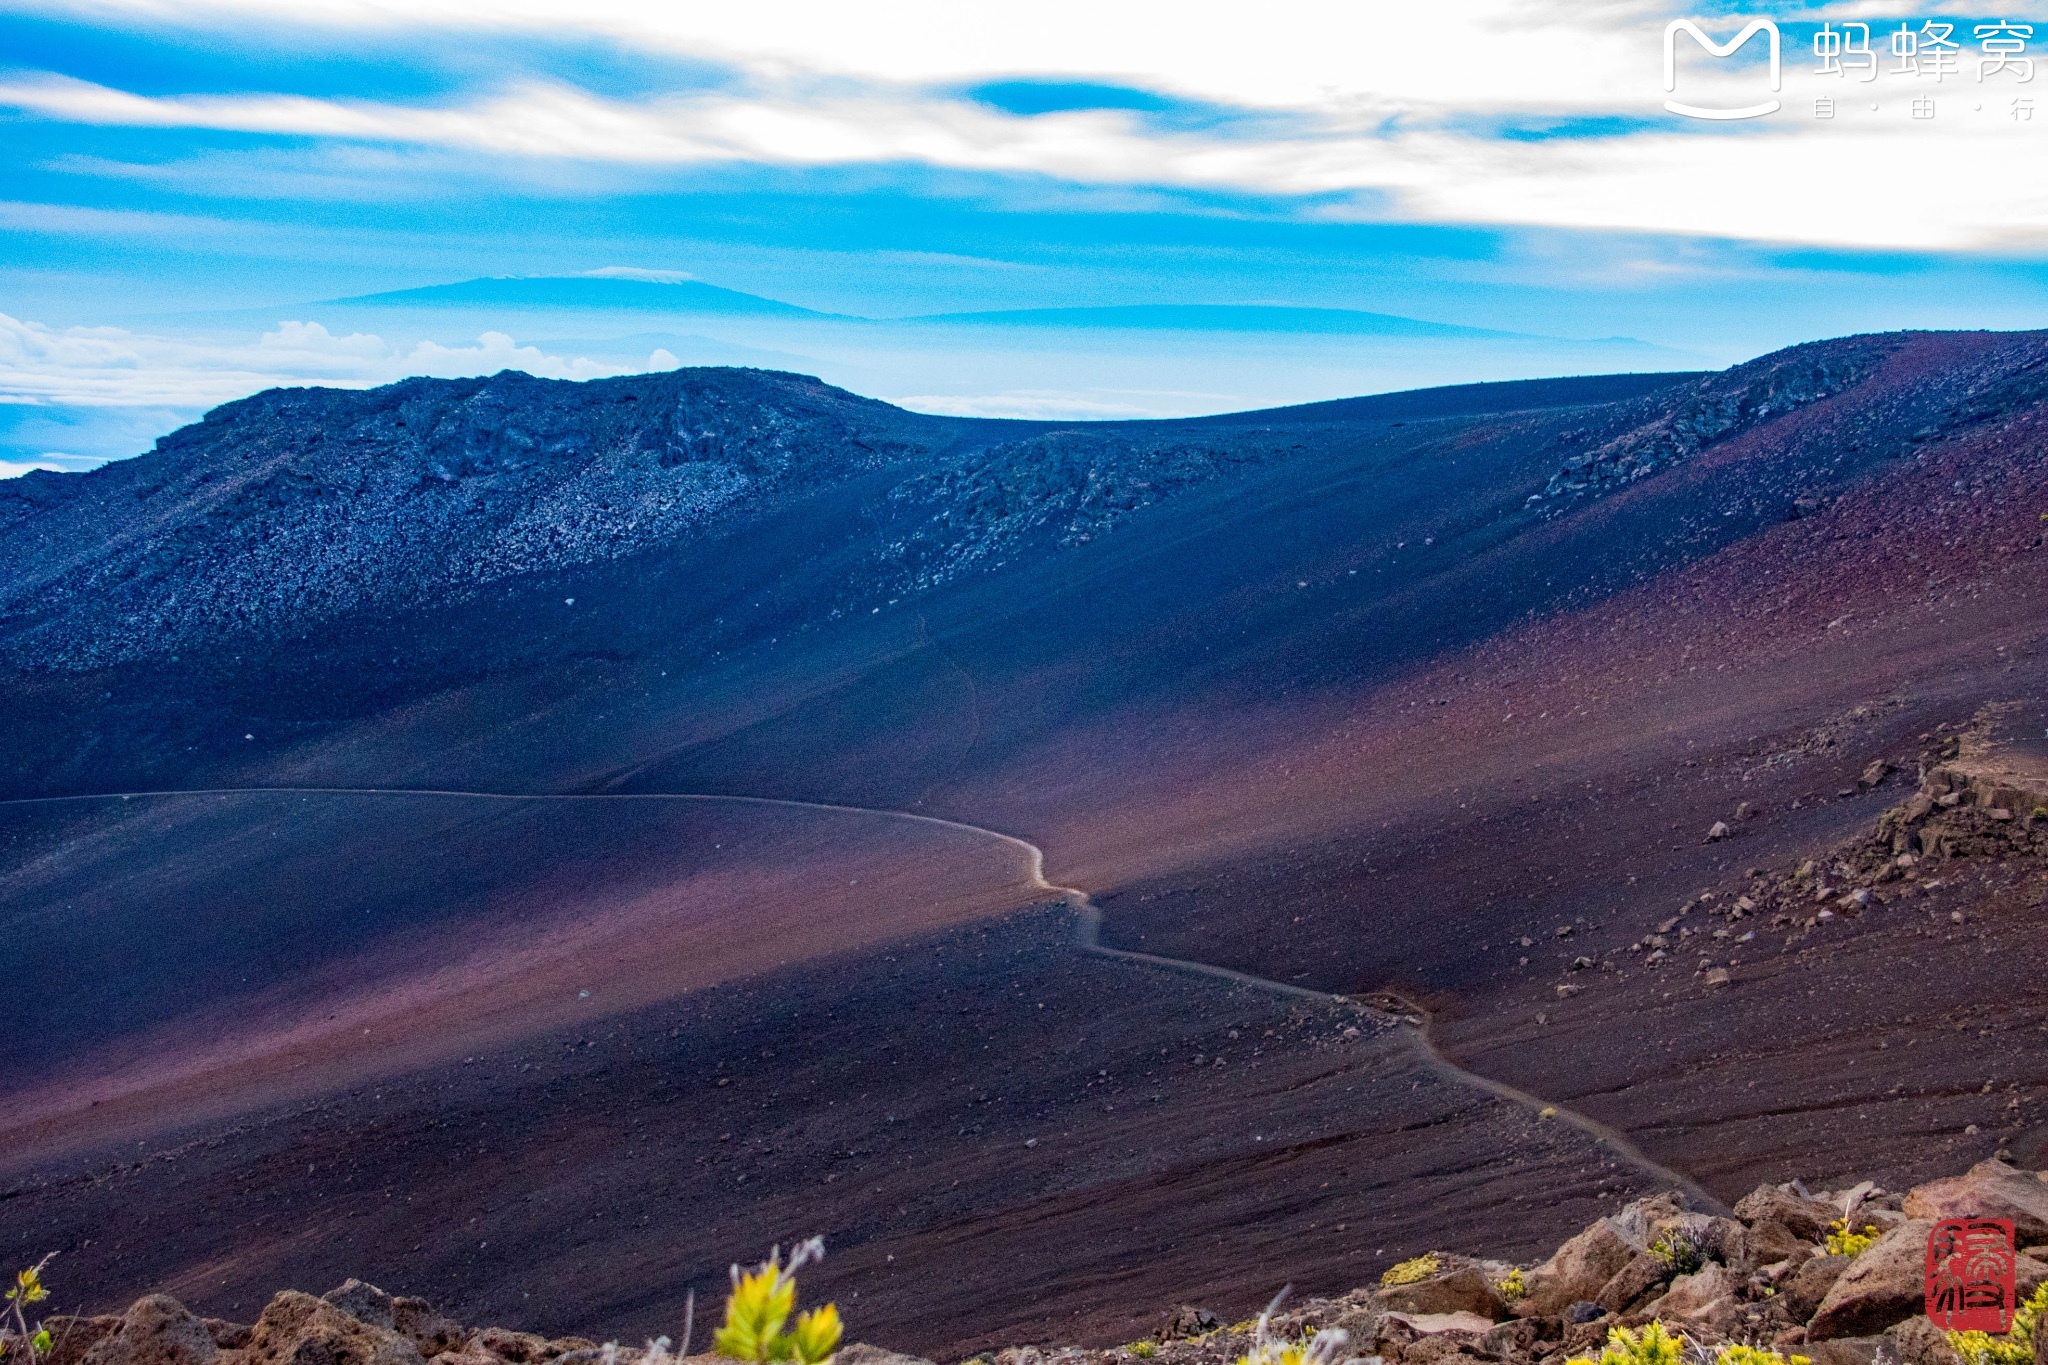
[0,0,2048,473]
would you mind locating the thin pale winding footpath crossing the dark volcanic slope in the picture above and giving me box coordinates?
[0,786,1729,1216]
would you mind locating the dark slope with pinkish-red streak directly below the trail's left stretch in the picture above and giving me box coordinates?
[0,792,1040,1121]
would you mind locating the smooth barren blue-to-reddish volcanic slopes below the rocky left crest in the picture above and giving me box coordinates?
[0,334,2048,1355]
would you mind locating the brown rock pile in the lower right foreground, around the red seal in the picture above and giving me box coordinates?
[993,1160,2048,1365]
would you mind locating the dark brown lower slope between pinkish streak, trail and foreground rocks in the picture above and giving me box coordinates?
[0,911,1642,1353]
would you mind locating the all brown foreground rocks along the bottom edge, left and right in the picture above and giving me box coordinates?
[45,1160,2048,1365]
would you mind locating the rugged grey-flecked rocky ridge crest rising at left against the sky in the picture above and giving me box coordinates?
[0,368,950,669]
